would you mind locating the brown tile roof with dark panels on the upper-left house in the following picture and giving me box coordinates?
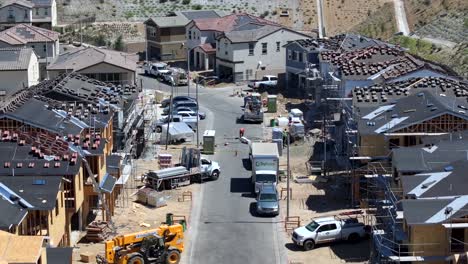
[0,24,60,45]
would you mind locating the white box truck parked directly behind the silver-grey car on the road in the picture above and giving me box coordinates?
[250,142,279,193]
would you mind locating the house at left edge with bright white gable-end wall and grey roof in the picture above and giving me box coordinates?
[0,48,39,97]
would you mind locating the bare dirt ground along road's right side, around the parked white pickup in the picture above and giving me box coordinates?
[265,96,370,264]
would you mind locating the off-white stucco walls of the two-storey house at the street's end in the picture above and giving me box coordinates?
[216,29,306,80]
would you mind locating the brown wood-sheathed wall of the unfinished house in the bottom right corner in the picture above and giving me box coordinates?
[409,224,450,264]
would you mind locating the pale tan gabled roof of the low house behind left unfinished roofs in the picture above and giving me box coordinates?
[47,47,136,71]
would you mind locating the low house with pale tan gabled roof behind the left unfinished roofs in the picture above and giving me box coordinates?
[47,47,137,85]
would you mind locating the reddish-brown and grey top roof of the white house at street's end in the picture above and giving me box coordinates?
[193,13,279,32]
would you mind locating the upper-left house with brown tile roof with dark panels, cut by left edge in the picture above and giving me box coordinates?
[0,24,60,79]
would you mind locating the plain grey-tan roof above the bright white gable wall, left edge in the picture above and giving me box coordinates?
[0,48,35,71]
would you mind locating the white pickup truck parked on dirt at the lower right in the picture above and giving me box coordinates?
[292,217,370,250]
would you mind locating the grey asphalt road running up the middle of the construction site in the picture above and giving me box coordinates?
[137,74,286,264]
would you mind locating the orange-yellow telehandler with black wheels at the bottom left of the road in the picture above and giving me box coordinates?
[96,224,184,264]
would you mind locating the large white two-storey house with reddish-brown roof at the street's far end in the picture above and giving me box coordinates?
[187,13,309,81]
